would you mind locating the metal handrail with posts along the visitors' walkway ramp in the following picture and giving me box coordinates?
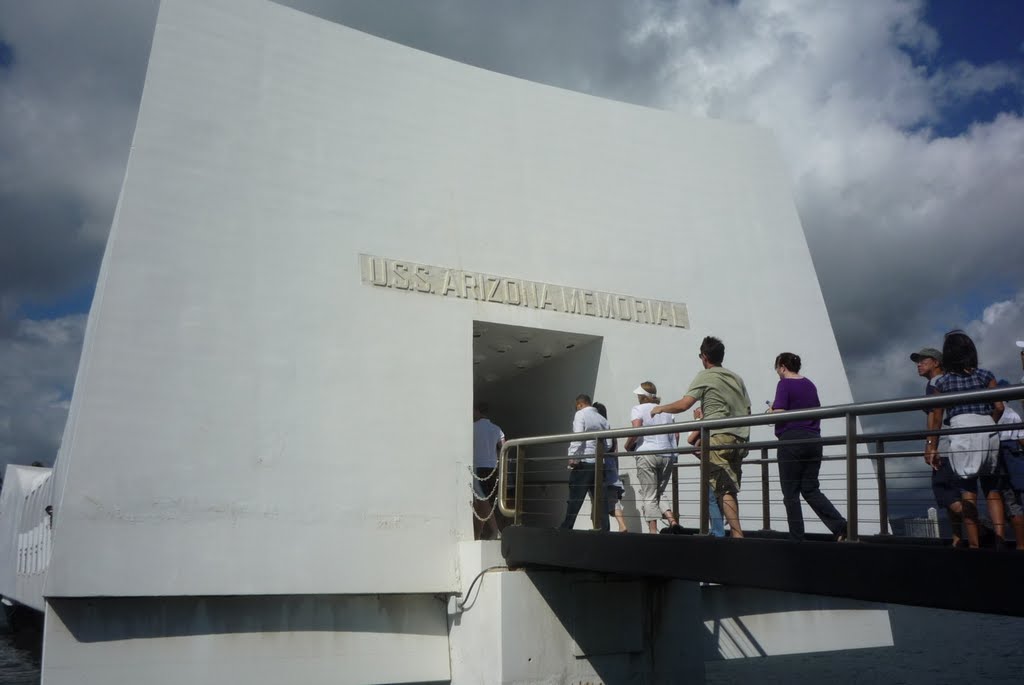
[498,385,1024,542]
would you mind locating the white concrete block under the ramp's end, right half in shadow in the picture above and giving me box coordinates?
[450,542,705,685]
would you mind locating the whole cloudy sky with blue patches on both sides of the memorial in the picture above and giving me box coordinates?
[0,0,1024,511]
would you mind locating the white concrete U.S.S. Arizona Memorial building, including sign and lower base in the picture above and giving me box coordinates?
[29,0,888,685]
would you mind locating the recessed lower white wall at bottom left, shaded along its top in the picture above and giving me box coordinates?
[43,595,451,685]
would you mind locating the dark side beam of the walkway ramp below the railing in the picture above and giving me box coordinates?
[502,526,1024,616]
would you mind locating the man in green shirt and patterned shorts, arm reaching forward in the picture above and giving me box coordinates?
[650,336,751,538]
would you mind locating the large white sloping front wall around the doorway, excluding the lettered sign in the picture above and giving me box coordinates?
[47,0,864,597]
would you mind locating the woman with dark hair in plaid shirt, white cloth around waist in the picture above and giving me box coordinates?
[925,331,1006,548]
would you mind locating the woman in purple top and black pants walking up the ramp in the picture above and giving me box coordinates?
[769,352,846,540]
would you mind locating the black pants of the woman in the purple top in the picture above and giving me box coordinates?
[778,429,846,540]
